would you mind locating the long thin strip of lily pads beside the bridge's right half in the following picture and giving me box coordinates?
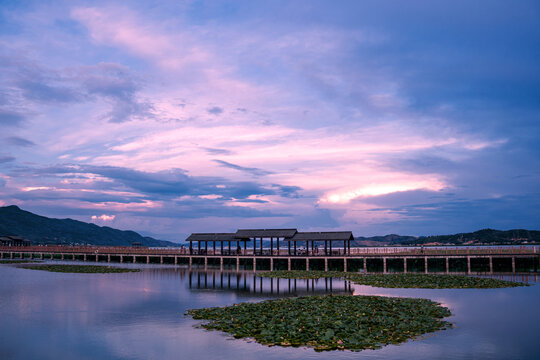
[258,270,529,289]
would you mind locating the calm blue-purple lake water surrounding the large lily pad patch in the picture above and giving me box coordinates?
[0,263,540,360]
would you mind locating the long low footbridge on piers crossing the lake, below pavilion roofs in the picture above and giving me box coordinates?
[0,245,540,274]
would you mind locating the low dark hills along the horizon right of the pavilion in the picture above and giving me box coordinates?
[351,229,540,246]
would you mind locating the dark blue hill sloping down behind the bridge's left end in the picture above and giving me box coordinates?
[0,205,179,247]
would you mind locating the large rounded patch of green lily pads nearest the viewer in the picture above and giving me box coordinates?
[186,295,451,351]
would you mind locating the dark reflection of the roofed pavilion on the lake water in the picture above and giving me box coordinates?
[188,271,353,296]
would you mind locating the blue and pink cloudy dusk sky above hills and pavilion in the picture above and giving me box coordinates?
[0,0,540,242]
